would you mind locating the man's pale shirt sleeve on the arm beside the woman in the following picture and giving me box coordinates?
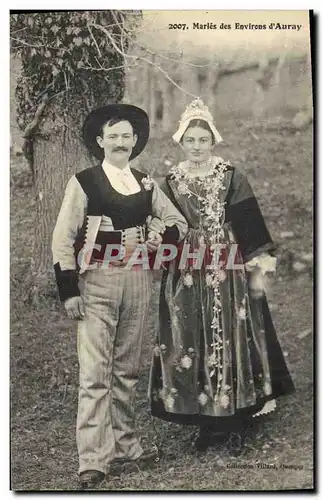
[152,181,188,241]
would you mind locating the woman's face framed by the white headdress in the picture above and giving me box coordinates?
[182,127,213,163]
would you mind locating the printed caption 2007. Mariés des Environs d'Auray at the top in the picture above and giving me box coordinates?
[168,22,302,31]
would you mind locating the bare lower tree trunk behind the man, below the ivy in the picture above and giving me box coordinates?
[31,111,92,302]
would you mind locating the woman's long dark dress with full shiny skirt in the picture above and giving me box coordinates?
[149,159,294,431]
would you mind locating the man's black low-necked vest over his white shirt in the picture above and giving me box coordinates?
[76,165,154,229]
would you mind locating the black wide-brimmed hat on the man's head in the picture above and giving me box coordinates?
[82,104,149,160]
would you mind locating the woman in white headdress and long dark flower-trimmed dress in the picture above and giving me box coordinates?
[149,99,294,450]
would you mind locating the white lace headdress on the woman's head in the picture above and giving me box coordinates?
[173,98,223,143]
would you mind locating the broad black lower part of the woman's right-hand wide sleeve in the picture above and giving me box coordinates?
[226,169,276,262]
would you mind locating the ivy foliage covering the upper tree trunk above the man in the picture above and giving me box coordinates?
[10,10,140,130]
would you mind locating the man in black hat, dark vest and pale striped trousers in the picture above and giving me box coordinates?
[52,104,187,488]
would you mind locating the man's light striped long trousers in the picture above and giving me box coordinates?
[76,267,152,473]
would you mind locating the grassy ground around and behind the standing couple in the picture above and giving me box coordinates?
[11,119,313,491]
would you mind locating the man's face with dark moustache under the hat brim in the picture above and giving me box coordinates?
[96,121,137,167]
